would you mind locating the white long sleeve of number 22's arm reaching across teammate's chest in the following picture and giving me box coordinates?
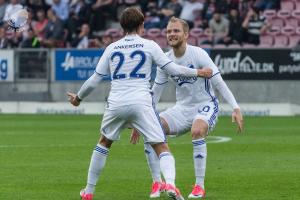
[152,42,197,77]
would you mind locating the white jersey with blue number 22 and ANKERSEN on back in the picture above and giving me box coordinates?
[95,35,172,107]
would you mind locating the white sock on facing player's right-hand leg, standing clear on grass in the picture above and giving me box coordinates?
[192,138,207,188]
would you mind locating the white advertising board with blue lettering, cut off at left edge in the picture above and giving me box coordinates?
[0,50,14,82]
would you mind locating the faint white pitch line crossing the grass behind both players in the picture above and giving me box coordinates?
[0,136,232,149]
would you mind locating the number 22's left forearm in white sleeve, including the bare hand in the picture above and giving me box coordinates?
[67,72,103,106]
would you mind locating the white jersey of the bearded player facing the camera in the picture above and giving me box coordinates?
[155,45,220,107]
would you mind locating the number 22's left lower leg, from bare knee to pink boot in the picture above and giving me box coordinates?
[80,135,113,200]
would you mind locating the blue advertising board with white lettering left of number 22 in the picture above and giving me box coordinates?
[55,49,109,81]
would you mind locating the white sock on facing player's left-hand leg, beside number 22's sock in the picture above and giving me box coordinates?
[144,144,161,182]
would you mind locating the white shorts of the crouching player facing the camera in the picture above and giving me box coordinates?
[160,100,219,136]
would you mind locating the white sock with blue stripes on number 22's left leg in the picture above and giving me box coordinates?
[85,144,109,194]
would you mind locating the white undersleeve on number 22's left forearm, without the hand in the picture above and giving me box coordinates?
[77,72,104,99]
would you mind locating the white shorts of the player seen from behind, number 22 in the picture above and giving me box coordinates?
[101,104,166,143]
